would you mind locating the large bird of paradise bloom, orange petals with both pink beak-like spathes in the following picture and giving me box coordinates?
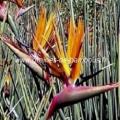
[1,7,120,120]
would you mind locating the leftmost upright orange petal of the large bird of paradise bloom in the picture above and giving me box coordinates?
[33,7,46,51]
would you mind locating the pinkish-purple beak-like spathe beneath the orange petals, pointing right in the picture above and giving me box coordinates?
[46,83,120,120]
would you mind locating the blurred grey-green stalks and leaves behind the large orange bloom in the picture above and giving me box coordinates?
[0,0,120,120]
